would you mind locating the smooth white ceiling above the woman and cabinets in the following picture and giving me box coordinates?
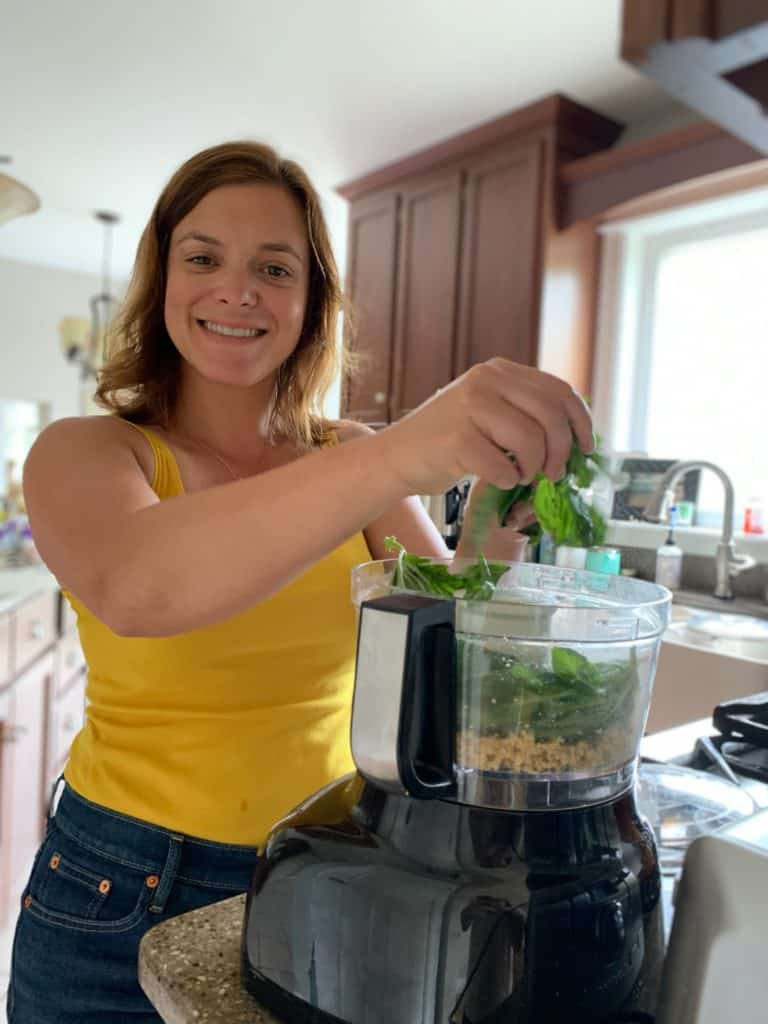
[0,0,692,276]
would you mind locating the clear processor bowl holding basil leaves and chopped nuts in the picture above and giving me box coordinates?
[352,559,672,809]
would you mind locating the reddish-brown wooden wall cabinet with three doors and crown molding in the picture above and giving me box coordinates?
[339,90,621,426]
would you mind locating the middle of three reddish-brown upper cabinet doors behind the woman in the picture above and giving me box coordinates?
[390,170,462,420]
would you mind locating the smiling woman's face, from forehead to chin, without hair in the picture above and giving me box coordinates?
[165,184,309,390]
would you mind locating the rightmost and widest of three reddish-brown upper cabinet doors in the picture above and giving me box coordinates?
[454,142,544,376]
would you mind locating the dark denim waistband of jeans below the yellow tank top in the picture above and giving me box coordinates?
[52,782,258,892]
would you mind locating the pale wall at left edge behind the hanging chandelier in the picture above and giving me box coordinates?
[0,260,108,419]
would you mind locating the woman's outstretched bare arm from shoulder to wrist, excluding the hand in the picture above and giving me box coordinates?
[25,417,415,636]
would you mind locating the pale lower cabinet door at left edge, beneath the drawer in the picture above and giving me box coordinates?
[0,651,53,919]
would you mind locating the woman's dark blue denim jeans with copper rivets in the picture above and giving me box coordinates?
[8,784,257,1024]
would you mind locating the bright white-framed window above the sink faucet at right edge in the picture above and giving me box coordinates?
[594,190,768,529]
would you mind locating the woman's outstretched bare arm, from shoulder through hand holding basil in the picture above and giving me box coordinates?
[25,359,592,636]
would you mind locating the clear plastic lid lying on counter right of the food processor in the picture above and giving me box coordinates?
[637,763,755,851]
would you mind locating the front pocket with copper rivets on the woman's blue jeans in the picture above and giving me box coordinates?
[24,825,152,933]
